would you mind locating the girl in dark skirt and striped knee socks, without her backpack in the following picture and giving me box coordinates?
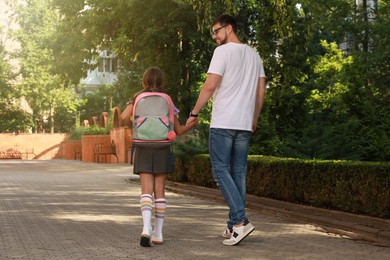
[121,67,197,247]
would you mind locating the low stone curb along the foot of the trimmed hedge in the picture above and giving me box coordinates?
[166,181,390,247]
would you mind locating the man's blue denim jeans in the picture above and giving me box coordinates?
[209,128,252,228]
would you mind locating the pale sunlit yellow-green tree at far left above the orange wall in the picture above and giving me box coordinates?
[7,0,80,133]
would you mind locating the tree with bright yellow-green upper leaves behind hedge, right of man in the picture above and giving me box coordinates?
[282,41,363,160]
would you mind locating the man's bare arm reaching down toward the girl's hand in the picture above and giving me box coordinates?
[187,73,222,123]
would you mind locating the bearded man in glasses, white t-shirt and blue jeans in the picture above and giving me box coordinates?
[187,15,265,246]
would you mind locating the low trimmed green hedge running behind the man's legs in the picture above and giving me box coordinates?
[169,155,390,218]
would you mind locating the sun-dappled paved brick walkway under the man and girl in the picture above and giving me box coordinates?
[0,160,390,260]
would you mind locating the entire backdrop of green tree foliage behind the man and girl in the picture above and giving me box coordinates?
[0,0,390,161]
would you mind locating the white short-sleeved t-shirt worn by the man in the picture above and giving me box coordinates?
[207,42,265,131]
